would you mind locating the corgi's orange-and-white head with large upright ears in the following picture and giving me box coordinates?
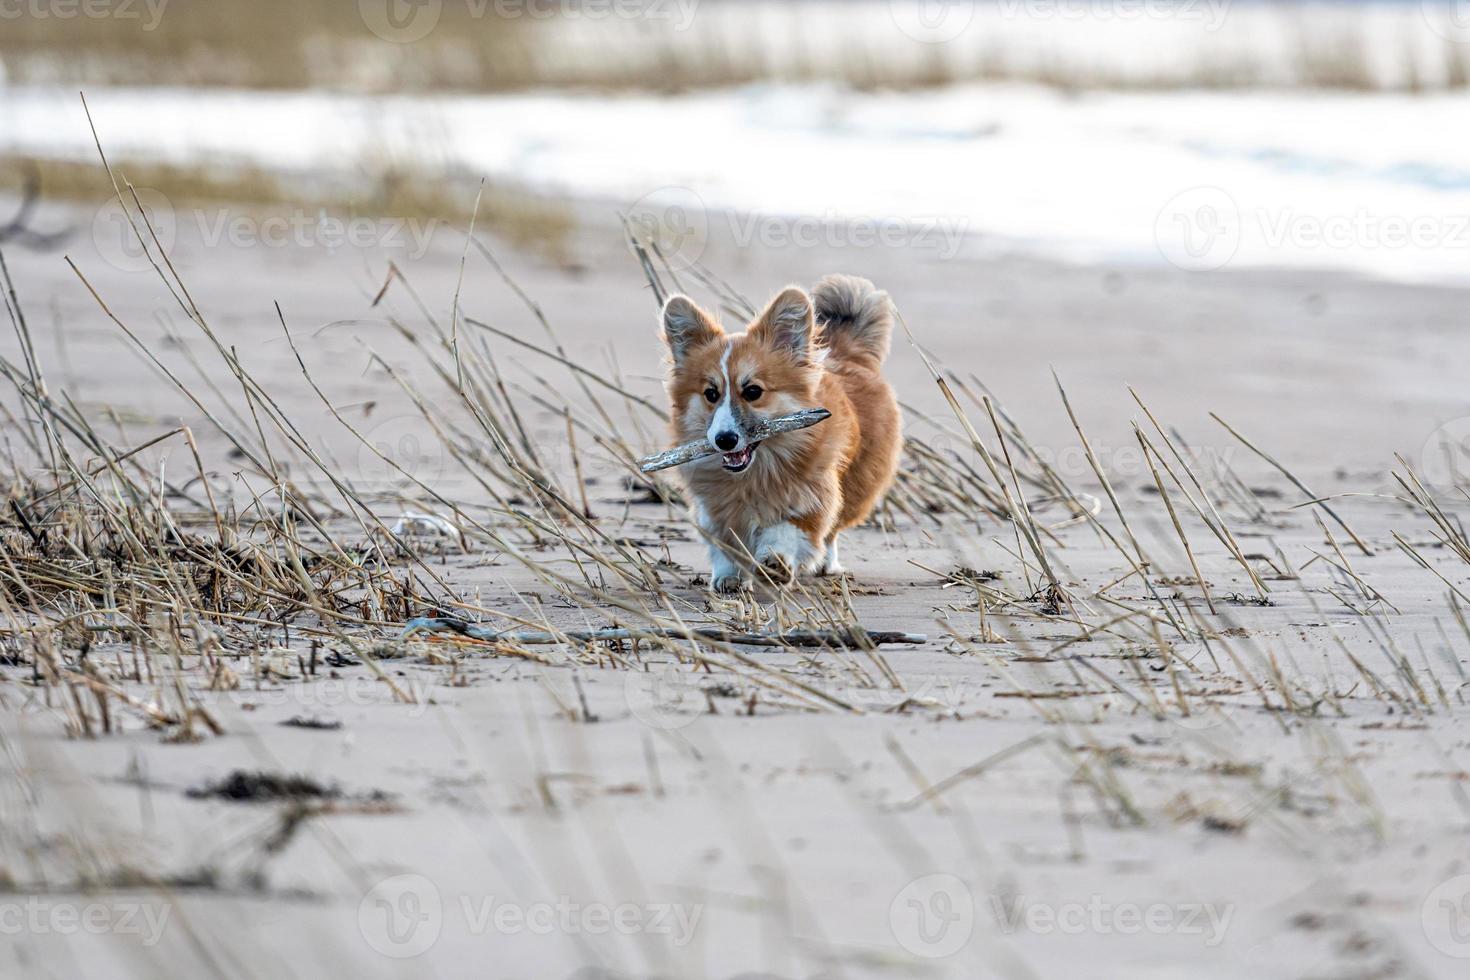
[660,287,822,473]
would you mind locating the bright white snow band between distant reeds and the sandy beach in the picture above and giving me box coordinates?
[0,85,1470,285]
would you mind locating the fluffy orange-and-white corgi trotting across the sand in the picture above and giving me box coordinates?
[660,276,903,592]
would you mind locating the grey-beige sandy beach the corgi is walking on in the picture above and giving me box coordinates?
[0,185,1470,980]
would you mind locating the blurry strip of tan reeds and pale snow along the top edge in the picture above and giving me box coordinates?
[0,0,1470,93]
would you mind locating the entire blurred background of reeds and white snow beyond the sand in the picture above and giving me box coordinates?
[0,0,1470,282]
